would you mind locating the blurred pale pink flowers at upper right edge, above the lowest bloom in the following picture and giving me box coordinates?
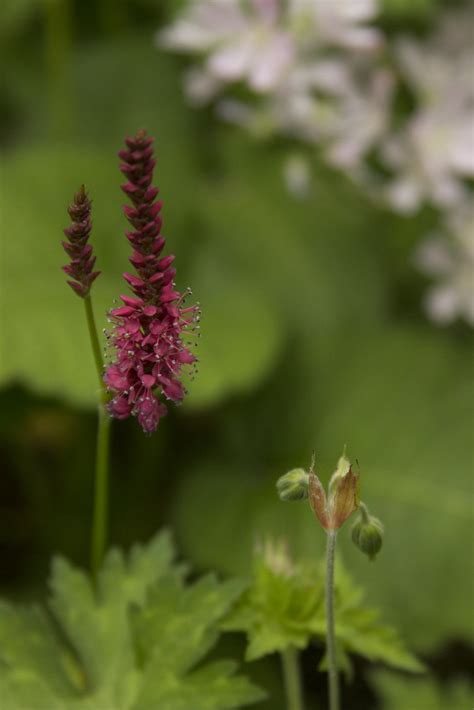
[382,13,474,213]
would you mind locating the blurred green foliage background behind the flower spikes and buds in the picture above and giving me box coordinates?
[0,0,473,710]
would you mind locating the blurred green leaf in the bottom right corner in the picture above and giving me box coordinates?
[371,671,474,710]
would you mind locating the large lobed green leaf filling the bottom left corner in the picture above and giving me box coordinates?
[0,533,263,710]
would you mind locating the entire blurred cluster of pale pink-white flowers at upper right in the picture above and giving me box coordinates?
[159,0,474,325]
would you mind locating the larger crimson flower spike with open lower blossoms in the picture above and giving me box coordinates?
[104,131,199,433]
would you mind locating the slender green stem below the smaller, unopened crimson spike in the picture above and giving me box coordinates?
[84,294,111,579]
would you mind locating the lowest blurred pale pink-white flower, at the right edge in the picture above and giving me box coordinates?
[415,201,474,326]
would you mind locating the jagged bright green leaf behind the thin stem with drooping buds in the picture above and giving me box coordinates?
[223,543,423,672]
